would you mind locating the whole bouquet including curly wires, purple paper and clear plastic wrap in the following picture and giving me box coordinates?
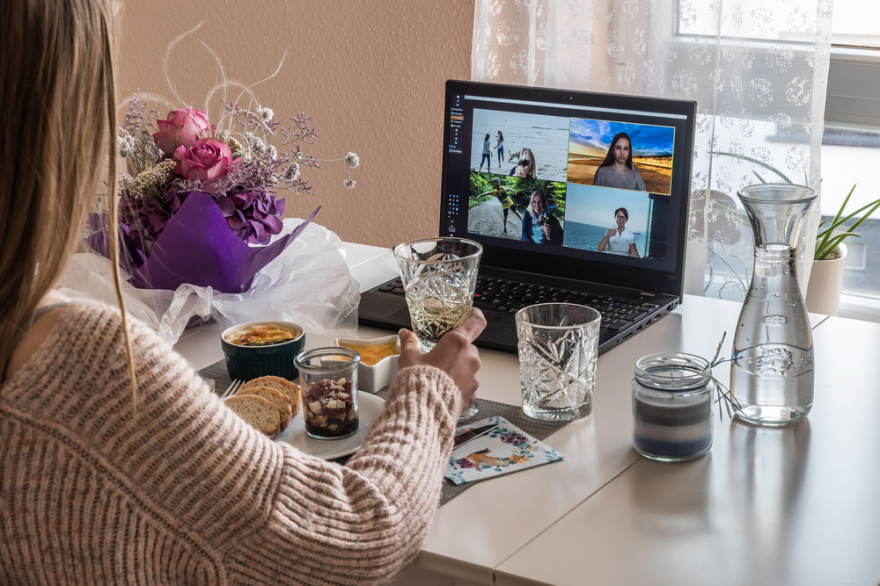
[69,25,360,344]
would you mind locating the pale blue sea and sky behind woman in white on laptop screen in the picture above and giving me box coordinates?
[563,183,651,258]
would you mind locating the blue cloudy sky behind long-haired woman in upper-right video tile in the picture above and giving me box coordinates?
[570,118,675,158]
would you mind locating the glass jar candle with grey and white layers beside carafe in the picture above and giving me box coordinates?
[632,352,715,462]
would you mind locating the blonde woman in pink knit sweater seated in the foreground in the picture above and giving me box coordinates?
[0,0,485,585]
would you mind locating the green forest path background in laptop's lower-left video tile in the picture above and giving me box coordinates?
[468,173,566,245]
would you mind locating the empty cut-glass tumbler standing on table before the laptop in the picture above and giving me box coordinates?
[516,303,602,421]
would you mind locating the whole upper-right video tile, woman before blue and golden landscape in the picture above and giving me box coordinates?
[568,118,675,195]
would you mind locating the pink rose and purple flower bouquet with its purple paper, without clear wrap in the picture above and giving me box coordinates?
[103,94,359,293]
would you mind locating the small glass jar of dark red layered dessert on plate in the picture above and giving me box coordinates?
[294,347,361,440]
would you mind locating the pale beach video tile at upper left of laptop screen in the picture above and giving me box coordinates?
[471,108,569,181]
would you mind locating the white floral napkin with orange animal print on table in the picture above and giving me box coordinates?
[446,416,565,484]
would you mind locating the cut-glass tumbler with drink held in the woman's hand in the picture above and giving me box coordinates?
[394,238,483,420]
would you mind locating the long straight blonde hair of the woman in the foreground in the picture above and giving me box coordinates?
[0,0,136,409]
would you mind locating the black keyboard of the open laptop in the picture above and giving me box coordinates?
[377,277,659,332]
